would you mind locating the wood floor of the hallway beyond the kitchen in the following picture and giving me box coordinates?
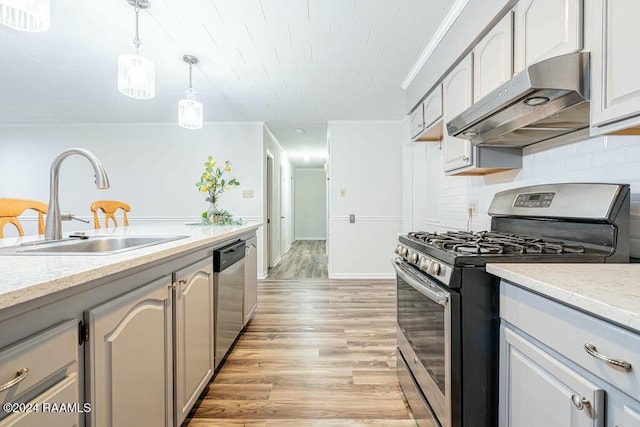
[267,240,329,280]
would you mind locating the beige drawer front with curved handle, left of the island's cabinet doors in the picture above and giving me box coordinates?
[0,320,78,406]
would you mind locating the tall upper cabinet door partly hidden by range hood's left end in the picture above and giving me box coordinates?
[443,53,473,172]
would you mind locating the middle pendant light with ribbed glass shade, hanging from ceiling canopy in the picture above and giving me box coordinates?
[117,0,156,99]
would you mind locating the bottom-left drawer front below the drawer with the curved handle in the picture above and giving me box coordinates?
[0,373,80,427]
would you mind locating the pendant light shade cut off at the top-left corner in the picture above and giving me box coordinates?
[0,0,51,33]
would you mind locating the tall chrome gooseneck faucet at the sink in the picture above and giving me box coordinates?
[44,148,109,240]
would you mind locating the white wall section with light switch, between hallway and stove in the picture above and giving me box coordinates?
[328,121,405,278]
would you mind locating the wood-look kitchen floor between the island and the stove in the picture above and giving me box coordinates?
[183,280,415,427]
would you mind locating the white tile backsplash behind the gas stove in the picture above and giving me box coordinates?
[404,136,640,257]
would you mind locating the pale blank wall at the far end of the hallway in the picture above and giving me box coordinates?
[293,168,327,240]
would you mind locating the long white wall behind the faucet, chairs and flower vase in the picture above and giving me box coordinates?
[0,122,263,266]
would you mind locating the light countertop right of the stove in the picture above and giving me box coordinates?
[487,264,640,332]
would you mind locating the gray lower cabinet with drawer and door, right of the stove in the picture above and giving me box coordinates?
[500,281,640,427]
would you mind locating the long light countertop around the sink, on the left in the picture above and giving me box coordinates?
[0,221,262,309]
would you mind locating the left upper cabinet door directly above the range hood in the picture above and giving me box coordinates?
[473,13,513,102]
